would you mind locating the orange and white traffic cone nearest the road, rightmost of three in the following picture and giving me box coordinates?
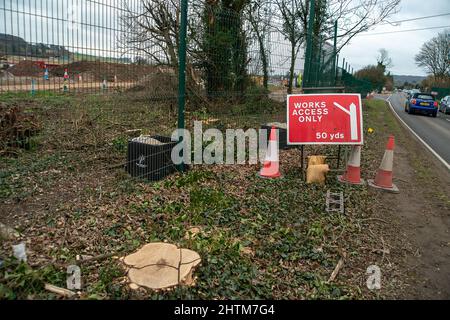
[368,136,400,193]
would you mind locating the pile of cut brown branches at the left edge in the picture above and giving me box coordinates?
[0,104,40,155]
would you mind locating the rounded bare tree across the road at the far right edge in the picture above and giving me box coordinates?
[416,31,450,80]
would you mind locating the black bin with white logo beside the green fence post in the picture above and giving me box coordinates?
[126,136,178,181]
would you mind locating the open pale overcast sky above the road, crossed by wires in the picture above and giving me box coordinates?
[341,0,450,76]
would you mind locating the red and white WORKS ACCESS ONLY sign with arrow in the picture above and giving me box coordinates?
[287,93,364,145]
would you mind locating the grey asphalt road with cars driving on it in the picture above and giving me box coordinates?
[383,93,450,168]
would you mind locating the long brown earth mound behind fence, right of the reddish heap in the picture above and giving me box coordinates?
[50,61,157,82]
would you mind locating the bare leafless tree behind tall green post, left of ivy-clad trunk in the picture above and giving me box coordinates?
[117,0,211,101]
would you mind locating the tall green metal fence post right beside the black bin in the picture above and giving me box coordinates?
[178,0,188,171]
